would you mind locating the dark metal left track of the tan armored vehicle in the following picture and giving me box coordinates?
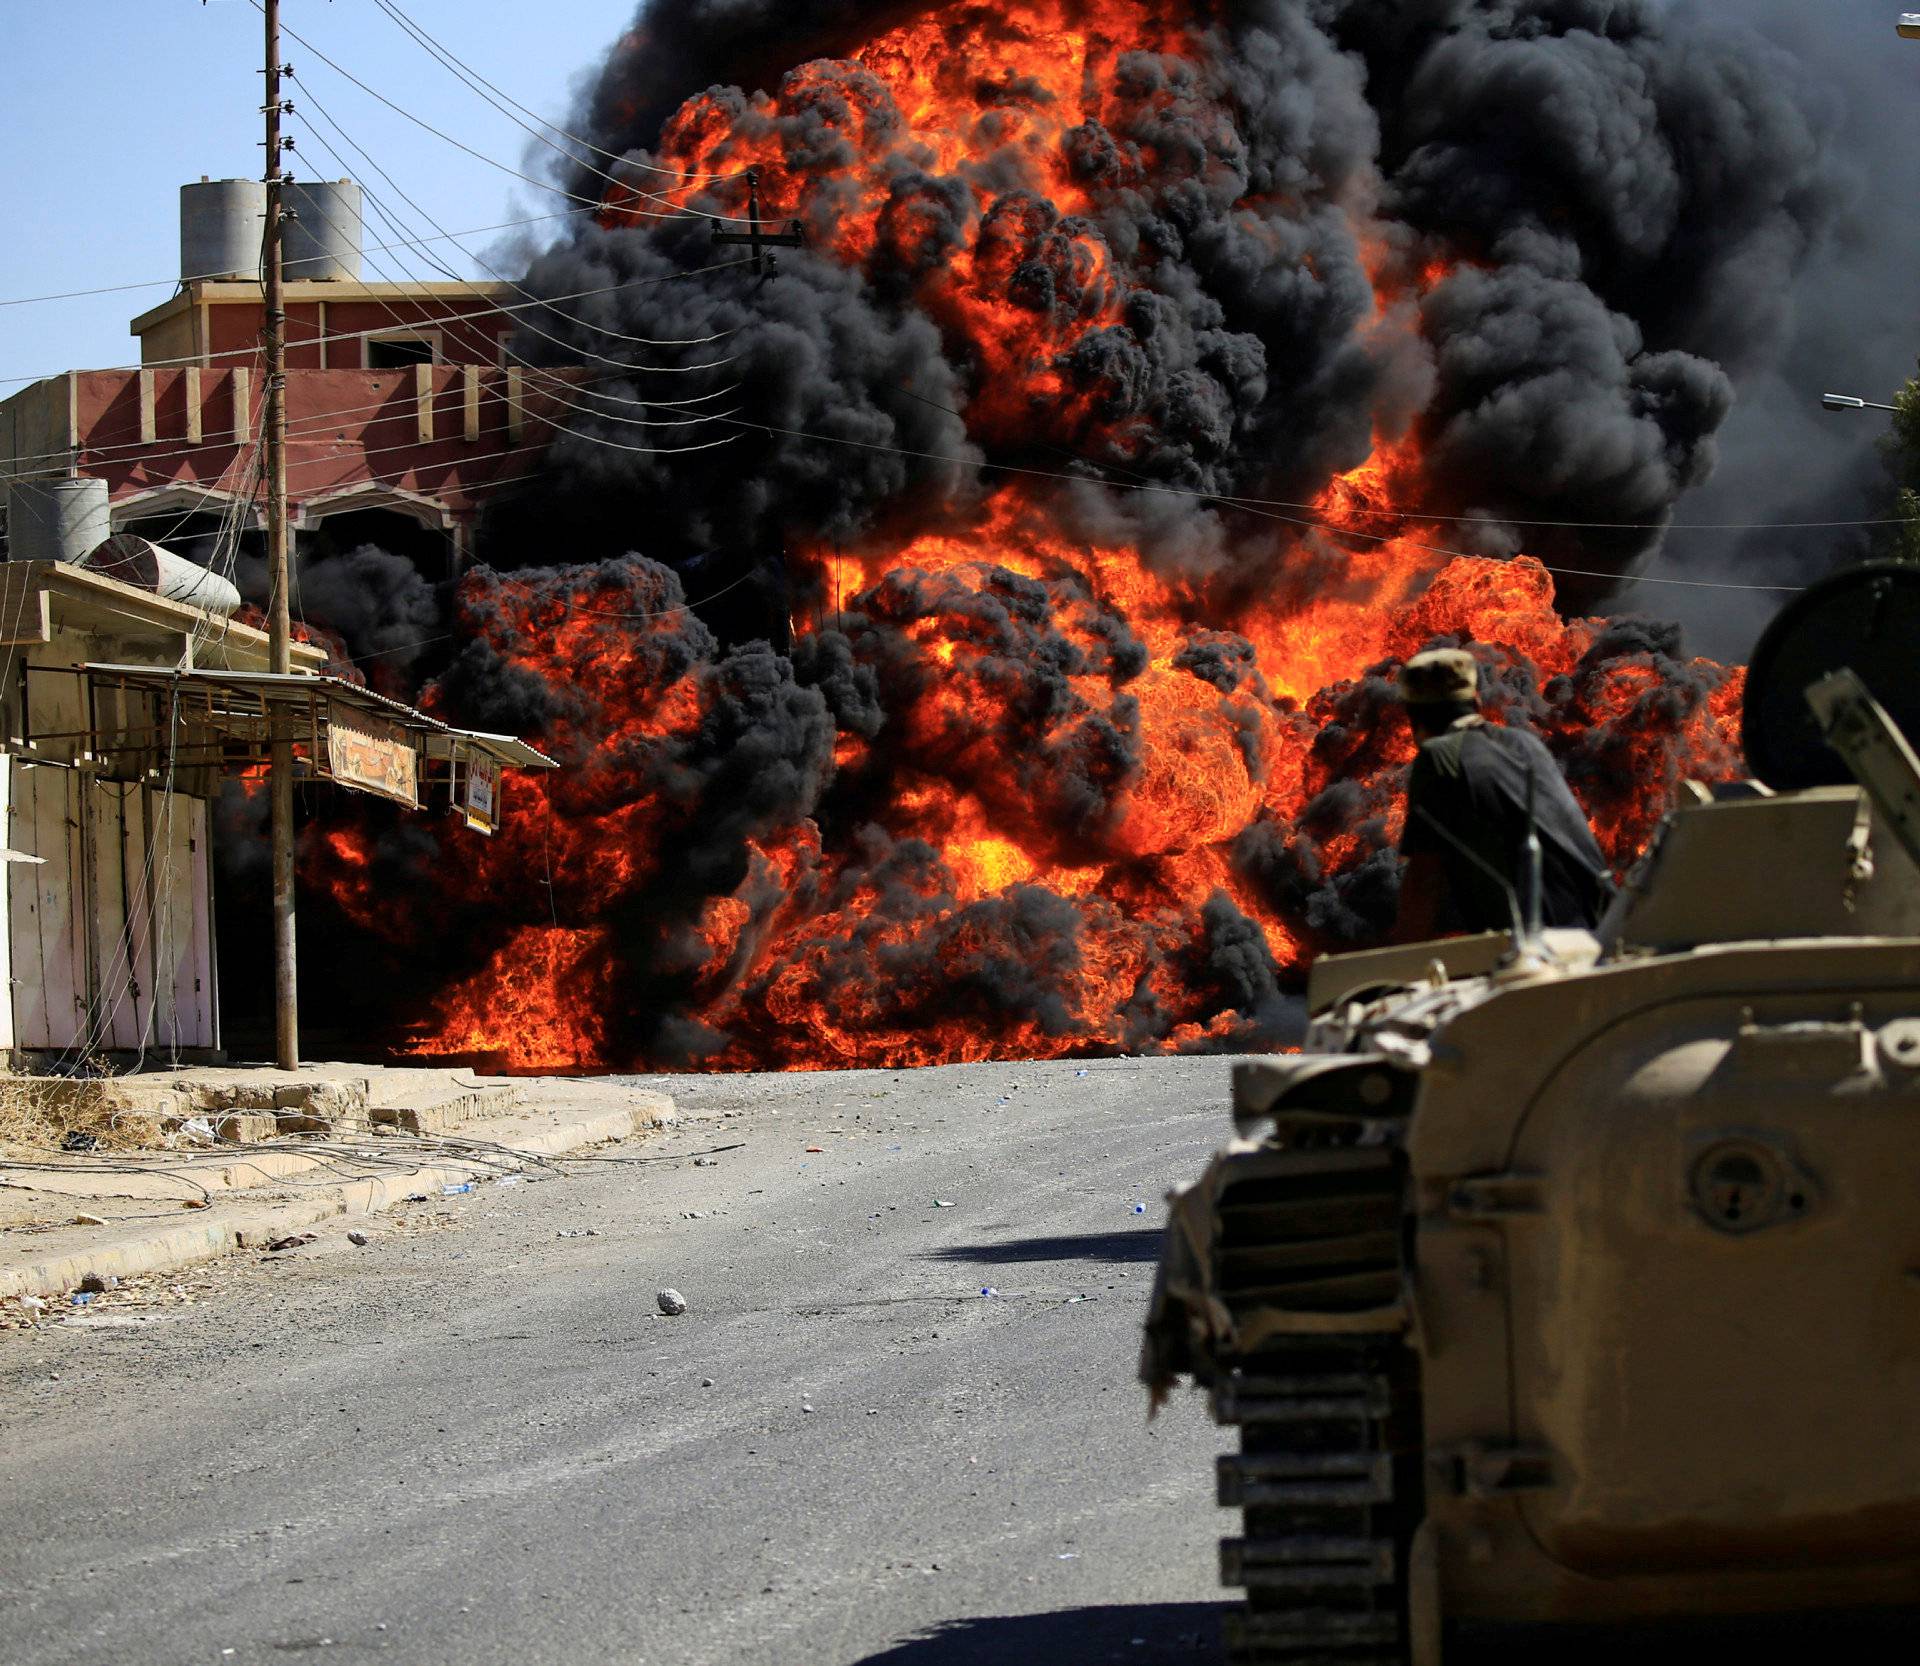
[1213,1146,1423,1666]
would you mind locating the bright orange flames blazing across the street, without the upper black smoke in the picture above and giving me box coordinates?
[311,0,1740,1069]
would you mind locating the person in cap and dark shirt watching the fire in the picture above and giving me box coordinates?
[1394,649,1613,942]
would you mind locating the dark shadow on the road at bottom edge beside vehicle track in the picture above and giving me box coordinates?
[858,1603,1227,1666]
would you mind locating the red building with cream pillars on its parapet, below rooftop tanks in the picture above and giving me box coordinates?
[0,262,566,578]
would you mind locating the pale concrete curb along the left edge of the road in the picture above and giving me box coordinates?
[0,1092,678,1299]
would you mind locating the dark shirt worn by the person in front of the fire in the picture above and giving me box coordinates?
[1400,716,1613,931]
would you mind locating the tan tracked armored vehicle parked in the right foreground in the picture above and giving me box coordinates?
[1142,564,1920,1666]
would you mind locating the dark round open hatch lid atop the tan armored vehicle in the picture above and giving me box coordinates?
[1740,560,1920,793]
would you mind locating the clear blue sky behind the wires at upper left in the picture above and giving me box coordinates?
[0,0,636,380]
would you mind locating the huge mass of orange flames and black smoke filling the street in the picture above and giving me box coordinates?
[288,0,1828,1067]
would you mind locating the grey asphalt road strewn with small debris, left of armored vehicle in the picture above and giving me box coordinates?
[0,1059,1231,1666]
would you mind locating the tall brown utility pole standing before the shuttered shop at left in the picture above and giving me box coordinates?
[261,0,300,1071]
